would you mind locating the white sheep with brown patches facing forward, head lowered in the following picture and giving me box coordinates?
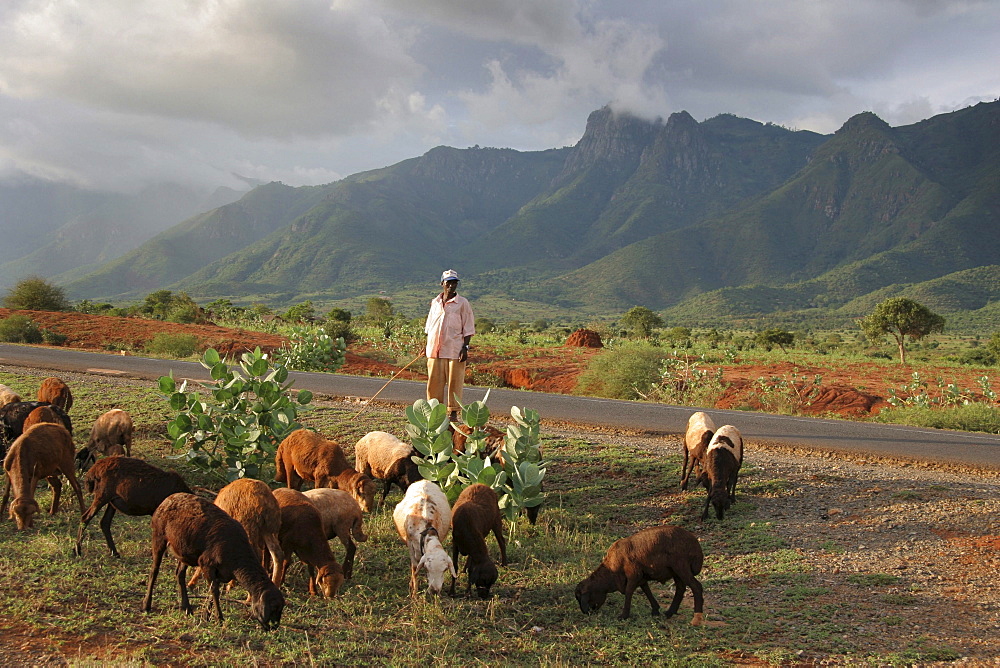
[392,480,458,596]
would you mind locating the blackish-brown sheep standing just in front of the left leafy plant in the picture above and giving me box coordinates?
[73,457,191,557]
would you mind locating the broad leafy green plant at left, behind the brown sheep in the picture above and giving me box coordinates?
[159,348,312,482]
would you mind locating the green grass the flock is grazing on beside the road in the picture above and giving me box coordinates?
[0,373,972,666]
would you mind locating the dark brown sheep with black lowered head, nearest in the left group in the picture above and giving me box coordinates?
[140,490,285,631]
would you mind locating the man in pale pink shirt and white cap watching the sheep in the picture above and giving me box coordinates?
[424,269,476,420]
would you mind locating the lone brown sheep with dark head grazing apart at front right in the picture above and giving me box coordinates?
[576,526,705,626]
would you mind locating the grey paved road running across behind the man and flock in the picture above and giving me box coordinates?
[0,344,1000,470]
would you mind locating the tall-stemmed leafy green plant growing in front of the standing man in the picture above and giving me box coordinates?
[406,399,545,526]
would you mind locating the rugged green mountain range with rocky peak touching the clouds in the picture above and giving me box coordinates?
[58,102,1000,328]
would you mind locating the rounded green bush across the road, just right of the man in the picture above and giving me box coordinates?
[576,346,667,399]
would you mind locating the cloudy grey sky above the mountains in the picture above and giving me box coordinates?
[0,0,1000,191]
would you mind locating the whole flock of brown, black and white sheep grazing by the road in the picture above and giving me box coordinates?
[0,378,743,630]
